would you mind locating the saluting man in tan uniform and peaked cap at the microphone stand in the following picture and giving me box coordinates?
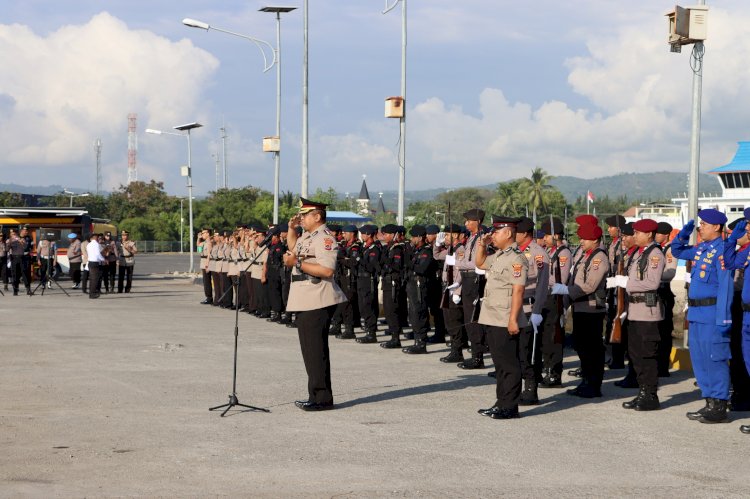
[284,198,346,411]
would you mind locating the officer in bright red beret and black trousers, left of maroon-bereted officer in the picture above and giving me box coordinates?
[552,222,609,398]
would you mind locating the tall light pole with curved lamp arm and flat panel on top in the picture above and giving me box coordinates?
[182,7,296,224]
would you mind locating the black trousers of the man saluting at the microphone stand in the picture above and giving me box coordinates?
[297,305,336,405]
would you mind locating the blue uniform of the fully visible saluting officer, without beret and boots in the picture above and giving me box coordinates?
[672,232,734,400]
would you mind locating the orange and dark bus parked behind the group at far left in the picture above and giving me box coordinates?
[0,208,117,274]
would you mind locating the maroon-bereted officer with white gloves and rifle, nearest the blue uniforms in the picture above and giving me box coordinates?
[607,218,665,411]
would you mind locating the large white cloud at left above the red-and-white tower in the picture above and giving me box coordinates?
[0,13,218,188]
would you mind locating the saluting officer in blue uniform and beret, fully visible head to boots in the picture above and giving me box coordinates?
[672,209,735,423]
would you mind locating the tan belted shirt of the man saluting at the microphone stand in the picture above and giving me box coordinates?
[286,225,346,312]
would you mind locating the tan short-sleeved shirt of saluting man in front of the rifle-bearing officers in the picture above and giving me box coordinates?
[478,243,529,329]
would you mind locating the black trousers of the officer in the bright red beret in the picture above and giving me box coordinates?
[573,311,604,389]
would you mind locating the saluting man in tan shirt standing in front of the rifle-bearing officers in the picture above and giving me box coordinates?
[476,215,529,419]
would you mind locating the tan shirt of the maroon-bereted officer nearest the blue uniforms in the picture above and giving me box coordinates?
[625,245,666,322]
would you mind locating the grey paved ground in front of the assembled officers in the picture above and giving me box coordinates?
[0,277,750,497]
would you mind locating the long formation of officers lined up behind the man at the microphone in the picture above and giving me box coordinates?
[198,200,750,431]
